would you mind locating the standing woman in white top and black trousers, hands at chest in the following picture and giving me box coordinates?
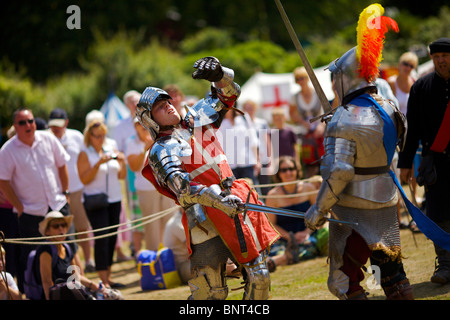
[77,121,126,288]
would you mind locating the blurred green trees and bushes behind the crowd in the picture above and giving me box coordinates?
[0,0,450,139]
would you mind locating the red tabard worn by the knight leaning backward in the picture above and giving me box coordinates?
[142,126,280,263]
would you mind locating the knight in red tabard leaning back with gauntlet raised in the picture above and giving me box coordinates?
[136,57,279,300]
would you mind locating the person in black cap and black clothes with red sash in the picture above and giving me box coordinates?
[398,38,450,284]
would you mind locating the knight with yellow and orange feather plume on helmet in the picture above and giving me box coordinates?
[305,4,413,300]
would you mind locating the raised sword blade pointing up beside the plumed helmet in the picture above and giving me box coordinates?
[275,0,331,113]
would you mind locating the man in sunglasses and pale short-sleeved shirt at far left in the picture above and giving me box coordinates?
[0,109,70,292]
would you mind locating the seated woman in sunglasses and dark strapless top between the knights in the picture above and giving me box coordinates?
[266,156,328,271]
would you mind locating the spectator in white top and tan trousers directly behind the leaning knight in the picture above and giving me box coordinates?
[125,118,173,252]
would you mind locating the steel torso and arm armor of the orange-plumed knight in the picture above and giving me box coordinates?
[321,97,404,209]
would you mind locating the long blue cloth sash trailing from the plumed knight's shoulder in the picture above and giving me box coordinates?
[350,94,450,250]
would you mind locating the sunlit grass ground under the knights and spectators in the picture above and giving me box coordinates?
[87,230,450,300]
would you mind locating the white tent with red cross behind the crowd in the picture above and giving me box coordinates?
[238,66,334,123]
